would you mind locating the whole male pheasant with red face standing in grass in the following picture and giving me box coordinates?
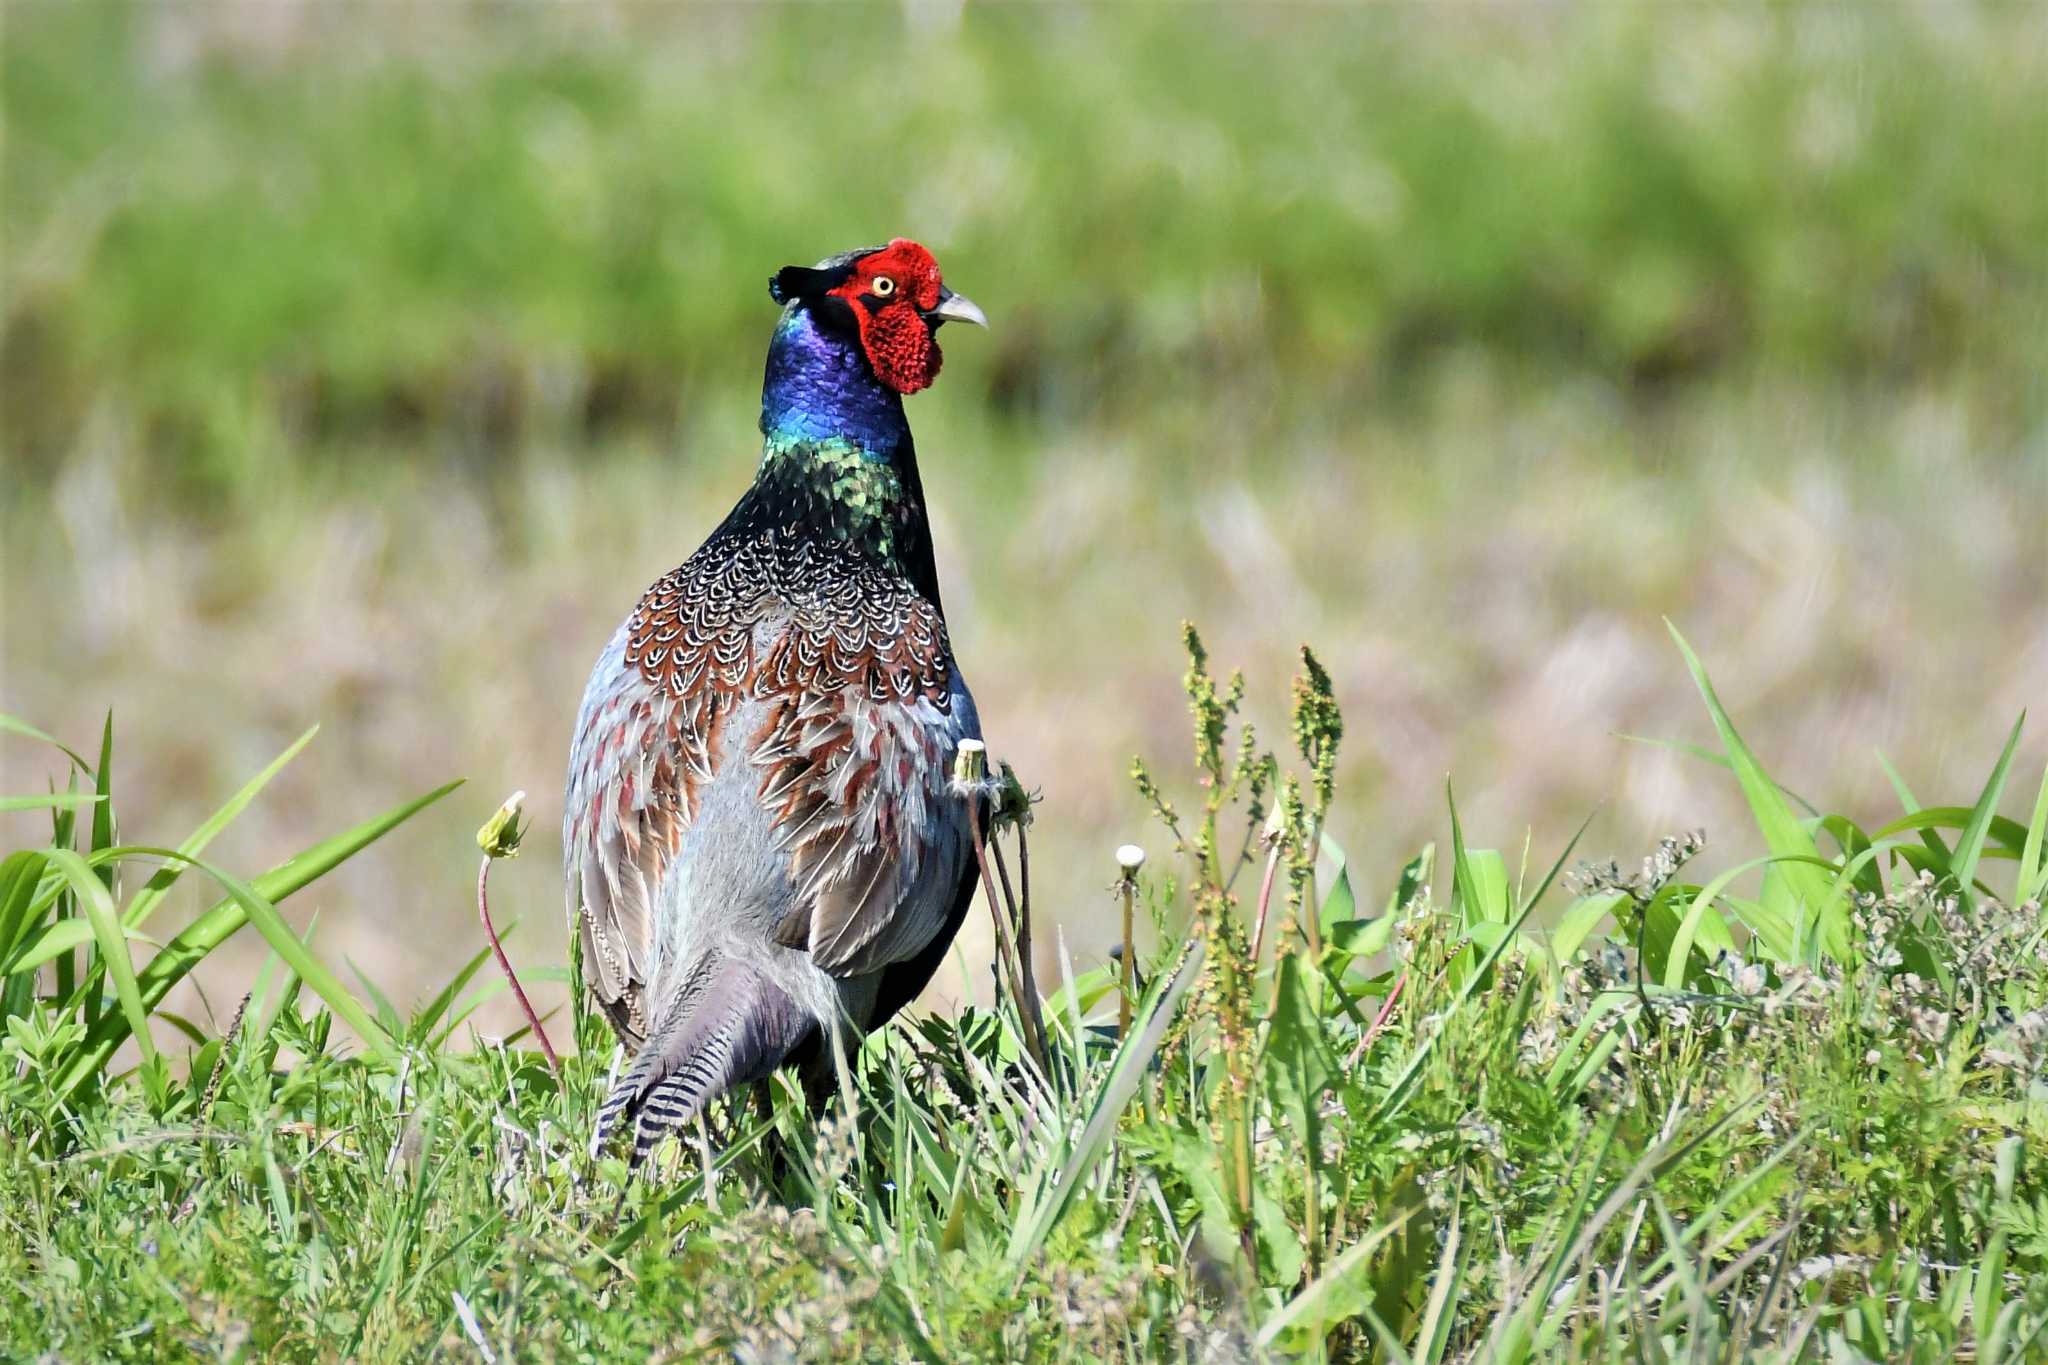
[561,239,987,1164]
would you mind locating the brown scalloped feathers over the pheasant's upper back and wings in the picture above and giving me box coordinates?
[573,526,952,1046]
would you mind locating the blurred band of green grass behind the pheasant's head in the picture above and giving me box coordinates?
[0,4,2048,493]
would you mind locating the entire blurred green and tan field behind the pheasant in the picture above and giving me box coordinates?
[0,2,2048,1035]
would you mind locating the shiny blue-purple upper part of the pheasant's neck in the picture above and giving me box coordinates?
[762,305,911,465]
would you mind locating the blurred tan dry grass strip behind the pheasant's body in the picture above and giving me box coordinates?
[0,374,2048,1027]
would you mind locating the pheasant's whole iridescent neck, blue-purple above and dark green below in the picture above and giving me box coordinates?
[753,303,938,604]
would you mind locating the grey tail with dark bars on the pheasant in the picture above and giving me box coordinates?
[590,950,815,1166]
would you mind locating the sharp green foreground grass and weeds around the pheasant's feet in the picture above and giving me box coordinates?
[0,630,2048,1361]
